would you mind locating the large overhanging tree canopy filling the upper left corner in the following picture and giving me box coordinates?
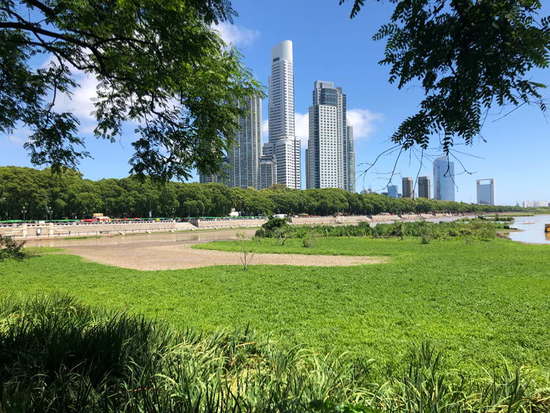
[0,0,259,180]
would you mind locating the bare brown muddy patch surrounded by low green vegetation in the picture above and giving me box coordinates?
[29,230,387,271]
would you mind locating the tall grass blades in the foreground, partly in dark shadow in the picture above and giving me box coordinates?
[0,296,550,413]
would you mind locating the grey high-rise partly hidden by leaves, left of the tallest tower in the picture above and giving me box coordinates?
[227,96,262,188]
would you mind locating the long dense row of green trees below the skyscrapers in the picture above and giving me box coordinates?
[0,167,522,219]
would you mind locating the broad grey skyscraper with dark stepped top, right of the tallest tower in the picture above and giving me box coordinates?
[306,81,355,189]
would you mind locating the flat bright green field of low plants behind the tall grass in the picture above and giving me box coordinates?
[0,238,550,382]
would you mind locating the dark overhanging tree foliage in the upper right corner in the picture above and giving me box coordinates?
[340,0,550,153]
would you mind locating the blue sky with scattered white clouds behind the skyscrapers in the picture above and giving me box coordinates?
[0,0,550,204]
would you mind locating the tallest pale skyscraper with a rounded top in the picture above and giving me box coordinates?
[263,40,301,189]
